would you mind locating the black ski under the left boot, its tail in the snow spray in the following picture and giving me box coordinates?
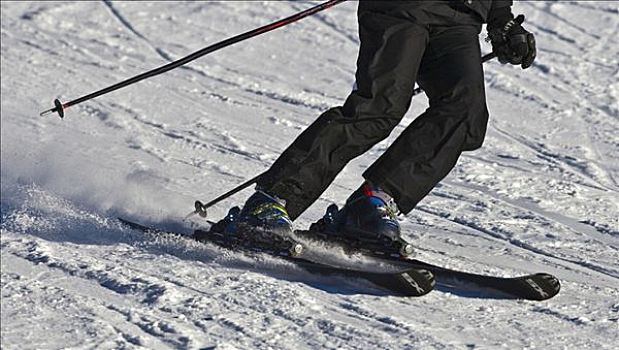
[118,218,435,297]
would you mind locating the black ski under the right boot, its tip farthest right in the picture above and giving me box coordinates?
[295,230,561,300]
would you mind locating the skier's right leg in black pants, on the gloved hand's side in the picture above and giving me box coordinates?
[364,25,488,213]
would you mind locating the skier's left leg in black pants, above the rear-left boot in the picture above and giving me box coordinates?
[258,9,428,219]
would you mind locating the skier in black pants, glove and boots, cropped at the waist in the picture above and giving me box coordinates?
[225,0,536,250]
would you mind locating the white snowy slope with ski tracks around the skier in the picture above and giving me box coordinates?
[0,1,619,349]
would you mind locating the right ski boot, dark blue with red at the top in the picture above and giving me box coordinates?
[309,183,413,257]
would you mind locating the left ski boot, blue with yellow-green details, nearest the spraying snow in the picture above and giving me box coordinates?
[201,190,304,256]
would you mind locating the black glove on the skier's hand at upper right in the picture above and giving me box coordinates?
[488,15,537,69]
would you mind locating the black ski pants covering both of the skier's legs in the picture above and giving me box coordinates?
[258,1,488,220]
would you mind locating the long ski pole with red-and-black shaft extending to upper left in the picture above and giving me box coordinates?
[40,0,346,118]
